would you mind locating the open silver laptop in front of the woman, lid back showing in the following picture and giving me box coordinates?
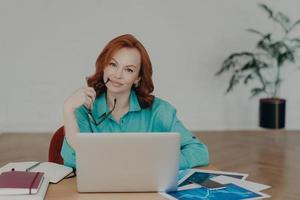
[75,132,180,192]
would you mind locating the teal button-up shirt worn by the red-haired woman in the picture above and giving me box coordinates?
[61,90,209,169]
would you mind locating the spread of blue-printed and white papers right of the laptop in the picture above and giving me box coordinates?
[161,169,271,200]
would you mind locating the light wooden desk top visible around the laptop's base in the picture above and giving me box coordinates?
[45,166,216,200]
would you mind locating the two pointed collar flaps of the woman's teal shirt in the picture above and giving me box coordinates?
[92,90,141,120]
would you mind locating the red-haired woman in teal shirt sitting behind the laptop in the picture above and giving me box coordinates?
[61,34,209,169]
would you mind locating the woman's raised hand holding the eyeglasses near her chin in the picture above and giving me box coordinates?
[64,87,96,111]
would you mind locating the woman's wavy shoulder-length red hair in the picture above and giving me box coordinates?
[87,34,154,108]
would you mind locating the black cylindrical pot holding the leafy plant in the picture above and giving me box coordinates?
[259,98,286,129]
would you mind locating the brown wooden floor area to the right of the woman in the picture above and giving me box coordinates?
[196,130,300,200]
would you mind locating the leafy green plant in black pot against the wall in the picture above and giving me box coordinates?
[216,4,300,129]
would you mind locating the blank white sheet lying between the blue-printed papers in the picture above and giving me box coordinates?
[211,175,271,192]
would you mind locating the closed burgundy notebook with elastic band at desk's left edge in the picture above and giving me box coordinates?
[0,171,44,195]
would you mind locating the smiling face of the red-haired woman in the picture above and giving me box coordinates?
[103,48,141,94]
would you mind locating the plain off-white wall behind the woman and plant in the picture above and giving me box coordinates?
[0,0,300,132]
